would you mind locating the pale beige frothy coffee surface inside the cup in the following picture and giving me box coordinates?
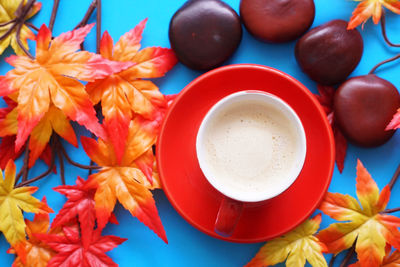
[203,100,301,194]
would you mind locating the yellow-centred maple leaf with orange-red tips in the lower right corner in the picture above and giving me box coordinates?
[318,161,400,267]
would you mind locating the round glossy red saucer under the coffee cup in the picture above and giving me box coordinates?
[157,64,335,243]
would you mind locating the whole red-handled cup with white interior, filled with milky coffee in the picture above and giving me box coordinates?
[196,90,307,236]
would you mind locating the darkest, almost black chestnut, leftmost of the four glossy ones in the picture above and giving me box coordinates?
[169,0,242,70]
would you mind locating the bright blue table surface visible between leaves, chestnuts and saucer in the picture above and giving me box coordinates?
[0,0,400,267]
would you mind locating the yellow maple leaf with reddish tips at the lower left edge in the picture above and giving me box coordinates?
[0,161,53,255]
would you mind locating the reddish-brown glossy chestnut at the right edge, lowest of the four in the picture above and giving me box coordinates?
[333,74,400,147]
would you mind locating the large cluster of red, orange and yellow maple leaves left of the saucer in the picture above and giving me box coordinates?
[0,1,177,266]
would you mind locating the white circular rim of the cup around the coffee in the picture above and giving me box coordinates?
[196,90,307,202]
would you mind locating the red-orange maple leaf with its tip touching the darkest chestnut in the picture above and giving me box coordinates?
[86,20,177,160]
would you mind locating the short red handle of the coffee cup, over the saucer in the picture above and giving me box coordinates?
[214,197,244,237]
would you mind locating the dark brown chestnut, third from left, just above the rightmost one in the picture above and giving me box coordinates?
[295,20,364,85]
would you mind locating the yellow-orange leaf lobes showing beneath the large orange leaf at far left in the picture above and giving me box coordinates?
[0,97,78,168]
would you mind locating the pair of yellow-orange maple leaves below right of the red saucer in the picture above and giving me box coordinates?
[247,161,400,267]
